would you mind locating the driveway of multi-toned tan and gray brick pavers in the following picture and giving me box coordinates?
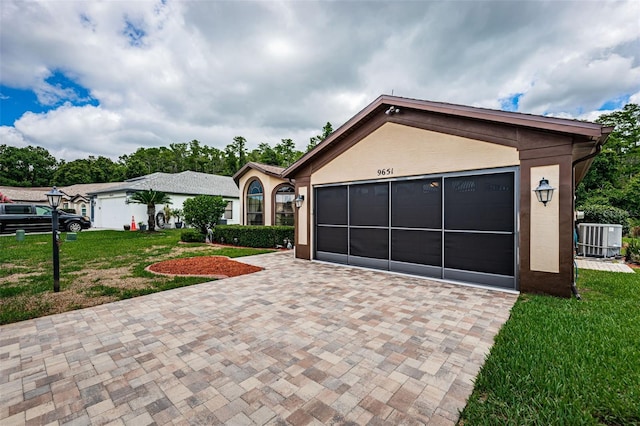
[0,252,516,426]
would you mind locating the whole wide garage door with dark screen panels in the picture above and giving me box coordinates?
[315,169,517,289]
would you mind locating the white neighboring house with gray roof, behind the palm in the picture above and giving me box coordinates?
[88,171,240,229]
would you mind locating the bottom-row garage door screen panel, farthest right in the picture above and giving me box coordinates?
[444,233,514,276]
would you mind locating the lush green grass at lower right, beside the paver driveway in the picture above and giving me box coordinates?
[460,270,640,425]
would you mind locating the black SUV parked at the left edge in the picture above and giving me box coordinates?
[0,203,91,234]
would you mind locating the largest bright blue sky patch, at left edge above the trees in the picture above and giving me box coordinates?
[0,71,100,126]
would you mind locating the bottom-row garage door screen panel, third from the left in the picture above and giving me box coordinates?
[391,229,442,267]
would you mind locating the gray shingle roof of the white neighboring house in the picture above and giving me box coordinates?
[89,171,240,198]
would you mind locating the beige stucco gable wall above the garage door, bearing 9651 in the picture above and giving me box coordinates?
[311,123,520,185]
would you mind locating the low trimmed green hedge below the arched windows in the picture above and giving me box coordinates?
[213,225,295,248]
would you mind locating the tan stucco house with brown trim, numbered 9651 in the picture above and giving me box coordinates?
[280,96,612,297]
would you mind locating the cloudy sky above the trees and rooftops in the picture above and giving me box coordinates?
[0,0,640,160]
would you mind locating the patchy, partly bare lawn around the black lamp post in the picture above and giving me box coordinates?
[0,230,273,324]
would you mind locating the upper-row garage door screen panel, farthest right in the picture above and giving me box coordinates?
[444,173,515,232]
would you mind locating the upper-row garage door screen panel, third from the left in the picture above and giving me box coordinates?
[391,178,442,229]
